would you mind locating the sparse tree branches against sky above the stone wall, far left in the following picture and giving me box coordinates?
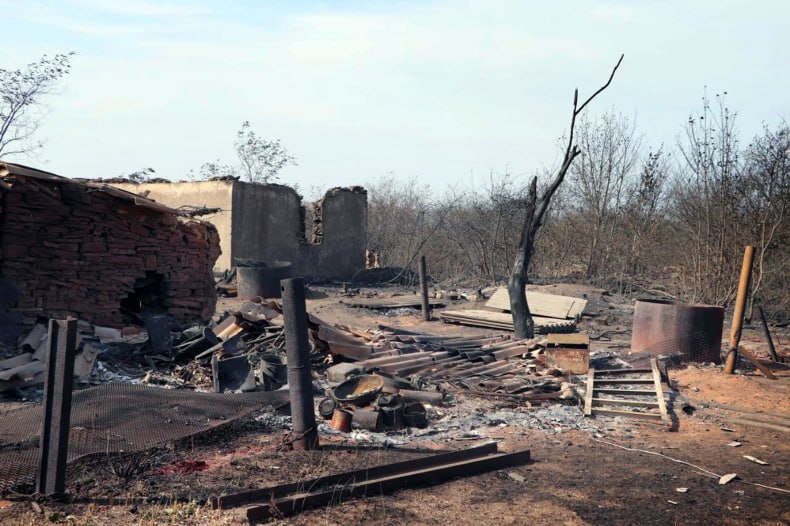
[0,52,74,157]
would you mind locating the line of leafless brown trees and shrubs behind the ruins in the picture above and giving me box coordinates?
[368,93,790,316]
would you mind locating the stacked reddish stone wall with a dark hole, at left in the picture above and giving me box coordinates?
[0,174,220,327]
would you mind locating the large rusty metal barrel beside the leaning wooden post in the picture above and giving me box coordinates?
[631,299,724,363]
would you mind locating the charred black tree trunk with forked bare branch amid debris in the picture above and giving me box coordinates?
[507,55,624,338]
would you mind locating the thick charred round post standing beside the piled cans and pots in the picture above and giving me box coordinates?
[280,278,318,449]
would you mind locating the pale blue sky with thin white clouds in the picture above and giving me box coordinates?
[0,0,790,196]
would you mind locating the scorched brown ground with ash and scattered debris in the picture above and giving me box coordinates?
[0,287,790,525]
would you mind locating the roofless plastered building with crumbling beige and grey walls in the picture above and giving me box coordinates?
[114,180,367,279]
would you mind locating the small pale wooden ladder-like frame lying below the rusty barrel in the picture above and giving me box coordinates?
[584,358,669,423]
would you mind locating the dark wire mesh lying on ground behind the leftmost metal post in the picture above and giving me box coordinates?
[0,383,288,493]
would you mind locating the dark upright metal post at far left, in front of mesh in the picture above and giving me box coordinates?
[37,318,77,498]
